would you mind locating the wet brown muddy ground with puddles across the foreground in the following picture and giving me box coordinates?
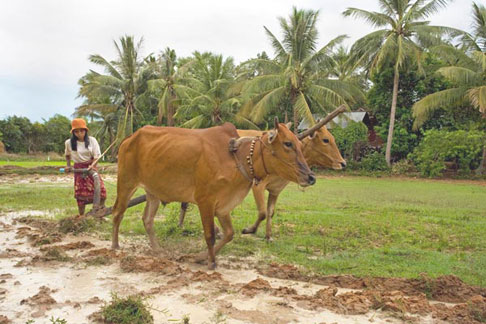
[0,211,486,323]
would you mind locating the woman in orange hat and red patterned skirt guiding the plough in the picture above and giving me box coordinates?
[65,118,106,216]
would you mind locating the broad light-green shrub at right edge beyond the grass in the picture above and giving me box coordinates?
[410,129,486,177]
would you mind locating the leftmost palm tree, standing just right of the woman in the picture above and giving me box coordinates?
[79,36,149,140]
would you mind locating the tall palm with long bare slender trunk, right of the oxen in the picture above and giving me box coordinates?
[343,0,452,166]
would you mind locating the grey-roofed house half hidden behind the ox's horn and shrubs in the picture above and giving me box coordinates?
[298,108,384,148]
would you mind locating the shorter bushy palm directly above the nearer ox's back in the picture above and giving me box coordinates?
[175,52,258,129]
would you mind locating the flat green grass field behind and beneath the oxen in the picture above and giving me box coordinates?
[0,176,486,287]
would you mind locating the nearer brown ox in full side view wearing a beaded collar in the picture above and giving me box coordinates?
[112,120,315,269]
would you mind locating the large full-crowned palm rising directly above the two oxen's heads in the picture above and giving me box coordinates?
[241,7,362,132]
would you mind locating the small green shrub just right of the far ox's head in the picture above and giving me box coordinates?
[330,121,368,160]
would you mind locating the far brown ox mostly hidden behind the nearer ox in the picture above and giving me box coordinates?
[179,126,346,240]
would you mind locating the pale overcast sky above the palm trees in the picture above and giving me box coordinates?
[0,0,474,121]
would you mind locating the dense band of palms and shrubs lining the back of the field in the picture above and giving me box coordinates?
[0,0,486,176]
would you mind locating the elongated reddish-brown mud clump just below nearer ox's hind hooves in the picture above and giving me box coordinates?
[120,256,183,275]
